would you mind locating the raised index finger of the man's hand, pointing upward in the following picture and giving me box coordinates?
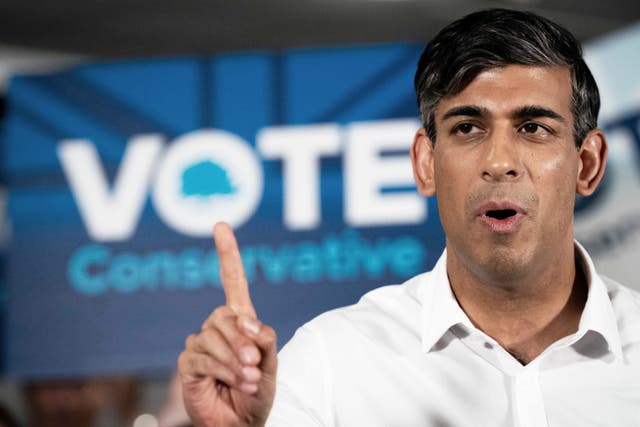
[213,222,256,319]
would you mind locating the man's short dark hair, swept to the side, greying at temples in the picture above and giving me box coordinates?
[414,9,600,147]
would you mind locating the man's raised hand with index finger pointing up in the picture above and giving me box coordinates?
[178,223,277,427]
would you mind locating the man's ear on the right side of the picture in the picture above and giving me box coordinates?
[576,129,608,196]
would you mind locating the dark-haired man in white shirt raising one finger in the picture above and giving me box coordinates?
[179,10,640,426]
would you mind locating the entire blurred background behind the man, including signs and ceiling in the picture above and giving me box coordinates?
[0,0,640,427]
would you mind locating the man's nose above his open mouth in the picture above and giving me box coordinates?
[482,131,523,181]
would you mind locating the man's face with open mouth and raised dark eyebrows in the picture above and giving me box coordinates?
[412,65,597,283]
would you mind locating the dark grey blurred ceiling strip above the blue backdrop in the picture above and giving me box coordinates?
[0,0,640,58]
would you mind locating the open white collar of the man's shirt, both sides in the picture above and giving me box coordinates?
[421,241,622,359]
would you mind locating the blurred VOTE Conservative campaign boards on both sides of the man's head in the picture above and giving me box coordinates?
[1,25,640,378]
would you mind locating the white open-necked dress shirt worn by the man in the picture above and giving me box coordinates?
[267,244,640,427]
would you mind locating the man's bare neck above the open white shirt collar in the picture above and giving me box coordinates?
[447,244,587,364]
